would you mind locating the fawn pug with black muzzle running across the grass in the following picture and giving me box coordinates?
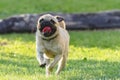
[36,14,70,76]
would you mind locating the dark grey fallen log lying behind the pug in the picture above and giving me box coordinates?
[0,10,120,33]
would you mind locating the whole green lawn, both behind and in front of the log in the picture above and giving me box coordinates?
[0,0,120,80]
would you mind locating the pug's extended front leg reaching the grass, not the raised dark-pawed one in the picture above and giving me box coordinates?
[46,55,61,76]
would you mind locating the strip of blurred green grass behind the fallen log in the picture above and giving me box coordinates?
[0,0,120,18]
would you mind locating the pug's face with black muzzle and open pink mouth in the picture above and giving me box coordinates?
[37,14,62,37]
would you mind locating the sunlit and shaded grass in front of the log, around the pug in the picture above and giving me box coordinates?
[0,30,120,80]
